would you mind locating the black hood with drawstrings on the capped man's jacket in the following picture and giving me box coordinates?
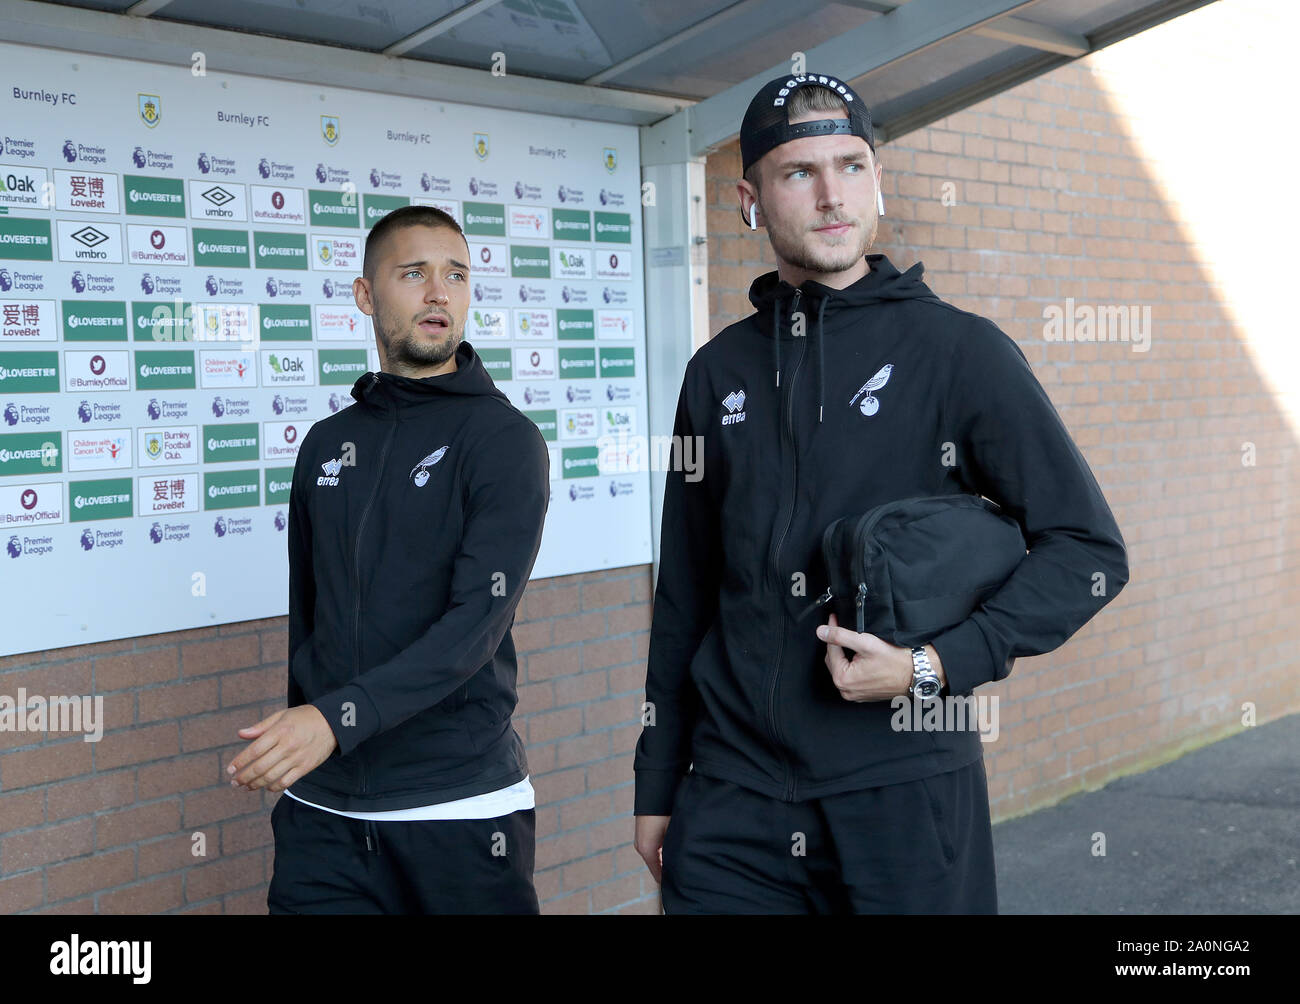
[749,254,939,423]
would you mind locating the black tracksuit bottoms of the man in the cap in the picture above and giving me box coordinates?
[663,757,997,914]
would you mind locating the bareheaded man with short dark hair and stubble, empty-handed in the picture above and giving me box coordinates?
[229,205,550,914]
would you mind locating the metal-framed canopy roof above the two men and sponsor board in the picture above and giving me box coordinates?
[10,0,1213,148]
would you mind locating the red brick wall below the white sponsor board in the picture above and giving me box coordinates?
[0,566,658,913]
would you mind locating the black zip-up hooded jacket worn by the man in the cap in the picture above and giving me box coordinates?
[633,254,1128,815]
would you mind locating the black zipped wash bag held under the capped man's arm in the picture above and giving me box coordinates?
[800,494,1026,648]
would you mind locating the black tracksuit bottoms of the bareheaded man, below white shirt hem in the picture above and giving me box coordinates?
[267,795,538,914]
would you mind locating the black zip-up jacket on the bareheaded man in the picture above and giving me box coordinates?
[289,342,550,812]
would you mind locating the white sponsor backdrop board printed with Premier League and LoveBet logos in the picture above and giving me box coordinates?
[0,43,651,654]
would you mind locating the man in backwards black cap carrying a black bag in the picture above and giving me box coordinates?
[634,74,1128,914]
